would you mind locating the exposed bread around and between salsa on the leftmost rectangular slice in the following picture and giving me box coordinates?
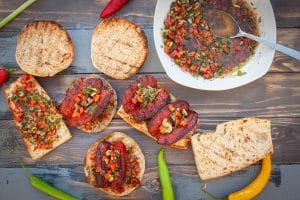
[5,75,72,160]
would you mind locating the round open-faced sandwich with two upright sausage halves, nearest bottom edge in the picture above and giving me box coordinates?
[84,132,145,196]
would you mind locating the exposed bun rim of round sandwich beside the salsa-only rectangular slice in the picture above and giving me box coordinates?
[61,74,117,133]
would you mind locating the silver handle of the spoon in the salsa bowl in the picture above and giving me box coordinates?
[239,31,300,60]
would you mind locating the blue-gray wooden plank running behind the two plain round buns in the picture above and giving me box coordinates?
[0,28,300,74]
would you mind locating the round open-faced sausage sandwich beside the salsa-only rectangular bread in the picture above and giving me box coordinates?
[60,75,117,133]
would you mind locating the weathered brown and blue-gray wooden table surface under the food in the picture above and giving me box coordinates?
[0,0,300,200]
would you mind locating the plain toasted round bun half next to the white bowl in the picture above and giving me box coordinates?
[91,18,148,79]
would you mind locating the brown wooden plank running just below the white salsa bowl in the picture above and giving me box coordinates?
[0,73,300,119]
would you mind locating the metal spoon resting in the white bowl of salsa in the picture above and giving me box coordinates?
[205,9,300,60]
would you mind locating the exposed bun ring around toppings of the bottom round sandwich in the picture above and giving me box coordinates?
[84,132,145,196]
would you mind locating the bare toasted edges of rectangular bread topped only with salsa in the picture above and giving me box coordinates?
[4,76,72,160]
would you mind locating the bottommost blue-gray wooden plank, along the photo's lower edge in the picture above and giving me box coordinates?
[0,164,300,200]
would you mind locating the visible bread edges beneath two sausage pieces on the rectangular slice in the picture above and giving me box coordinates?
[117,95,198,149]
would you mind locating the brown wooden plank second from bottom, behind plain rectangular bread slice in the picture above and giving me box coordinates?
[0,116,300,167]
